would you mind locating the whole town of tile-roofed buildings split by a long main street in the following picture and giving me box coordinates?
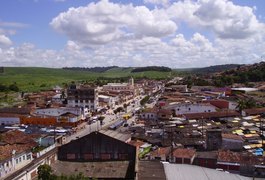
[0,71,265,180]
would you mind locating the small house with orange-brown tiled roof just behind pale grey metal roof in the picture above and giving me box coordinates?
[173,148,196,164]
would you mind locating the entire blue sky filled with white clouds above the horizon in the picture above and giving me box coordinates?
[0,0,265,68]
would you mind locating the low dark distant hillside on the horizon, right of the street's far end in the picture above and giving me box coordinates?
[189,64,238,74]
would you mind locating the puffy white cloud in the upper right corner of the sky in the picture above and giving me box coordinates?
[167,0,265,39]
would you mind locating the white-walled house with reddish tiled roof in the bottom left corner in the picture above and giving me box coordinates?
[0,130,37,179]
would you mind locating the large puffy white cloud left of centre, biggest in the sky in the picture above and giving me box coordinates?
[50,0,177,45]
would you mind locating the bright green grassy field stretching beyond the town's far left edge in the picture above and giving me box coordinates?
[0,67,178,92]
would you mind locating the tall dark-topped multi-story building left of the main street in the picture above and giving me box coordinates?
[67,85,98,111]
